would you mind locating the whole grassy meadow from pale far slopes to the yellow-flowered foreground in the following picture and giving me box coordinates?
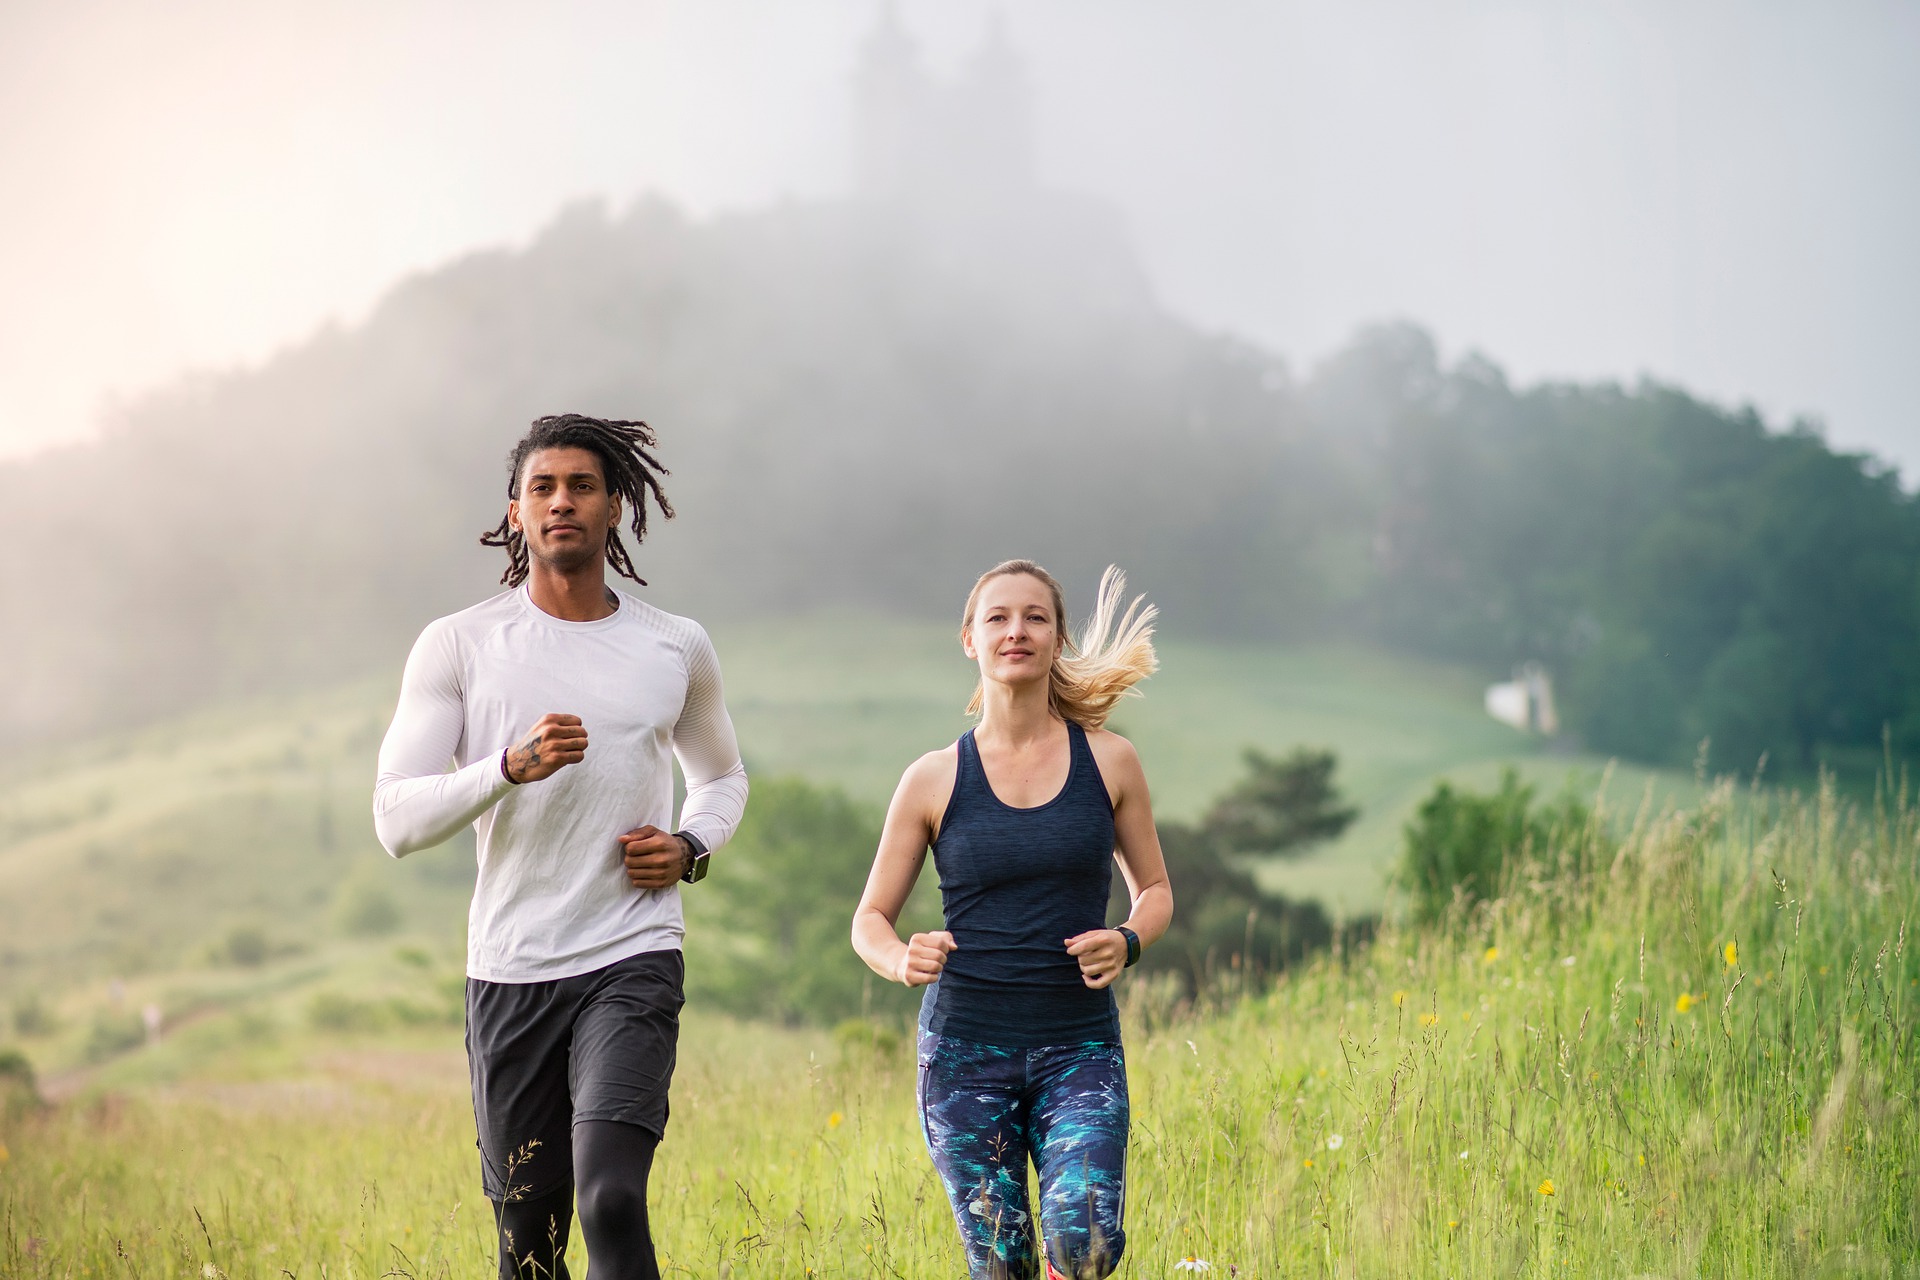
[11,620,1920,1280]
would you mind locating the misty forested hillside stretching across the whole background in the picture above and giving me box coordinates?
[0,196,1920,768]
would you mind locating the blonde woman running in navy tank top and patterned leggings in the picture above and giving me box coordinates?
[852,560,1173,1280]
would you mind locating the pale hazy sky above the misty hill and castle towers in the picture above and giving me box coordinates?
[0,0,1920,470]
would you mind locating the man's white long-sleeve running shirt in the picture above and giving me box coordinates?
[372,587,747,983]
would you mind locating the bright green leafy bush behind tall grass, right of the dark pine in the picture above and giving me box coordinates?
[1398,768,1597,921]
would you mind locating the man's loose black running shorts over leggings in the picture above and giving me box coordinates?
[467,952,685,1199]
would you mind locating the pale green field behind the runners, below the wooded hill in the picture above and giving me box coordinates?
[0,618,1693,1020]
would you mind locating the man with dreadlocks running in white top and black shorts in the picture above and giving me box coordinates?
[372,415,747,1280]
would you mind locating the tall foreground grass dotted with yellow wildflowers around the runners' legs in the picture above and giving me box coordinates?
[0,785,1920,1278]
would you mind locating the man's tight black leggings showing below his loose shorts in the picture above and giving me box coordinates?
[493,1121,660,1280]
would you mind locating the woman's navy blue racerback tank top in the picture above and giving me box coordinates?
[920,720,1119,1048]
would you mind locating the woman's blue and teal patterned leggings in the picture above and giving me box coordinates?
[920,1032,1127,1280]
